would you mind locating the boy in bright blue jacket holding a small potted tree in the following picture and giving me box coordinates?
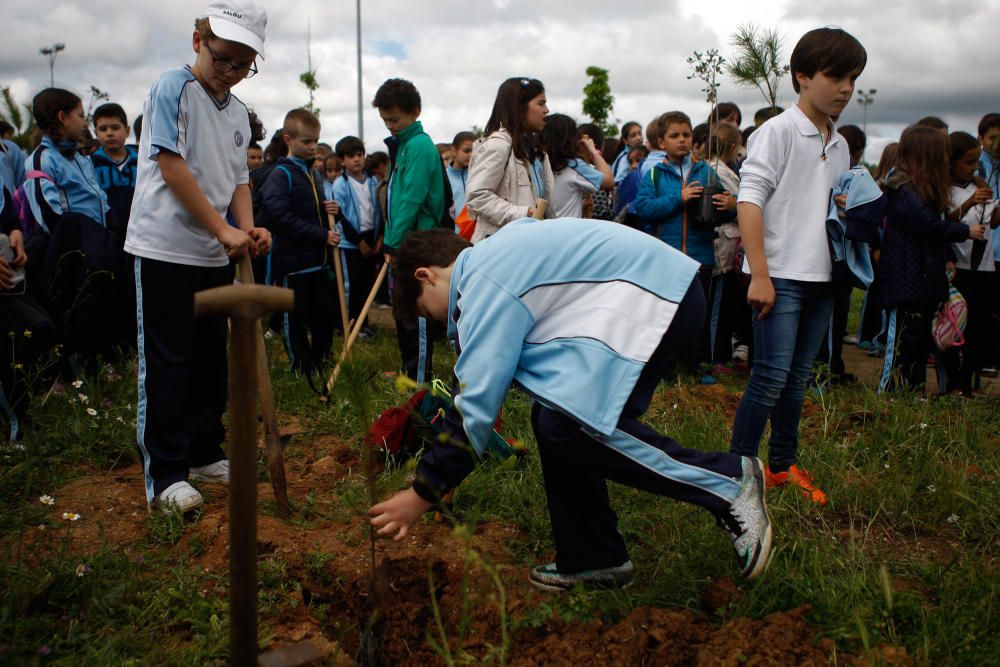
[635,111,736,384]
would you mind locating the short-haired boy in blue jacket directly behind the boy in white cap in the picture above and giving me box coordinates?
[90,102,139,240]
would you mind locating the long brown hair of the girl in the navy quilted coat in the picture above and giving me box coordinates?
[896,126,951,213]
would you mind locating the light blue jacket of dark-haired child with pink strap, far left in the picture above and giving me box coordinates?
[25,135,109,232]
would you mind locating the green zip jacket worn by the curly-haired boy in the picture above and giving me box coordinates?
[384,121,445,253]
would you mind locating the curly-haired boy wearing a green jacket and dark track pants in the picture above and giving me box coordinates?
[372,79,454,382]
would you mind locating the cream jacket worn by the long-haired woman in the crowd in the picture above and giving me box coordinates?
[465,128,555,243]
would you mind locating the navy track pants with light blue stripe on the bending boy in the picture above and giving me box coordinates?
[531,280,742,574]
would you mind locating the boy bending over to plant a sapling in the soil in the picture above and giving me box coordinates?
[370,218,771,590]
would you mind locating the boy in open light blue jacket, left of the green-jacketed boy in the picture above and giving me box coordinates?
[332,137,382,337]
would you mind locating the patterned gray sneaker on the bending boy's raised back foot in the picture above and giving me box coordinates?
[717,456,771,579]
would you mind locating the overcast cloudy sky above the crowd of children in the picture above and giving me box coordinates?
[0,0,1000,160]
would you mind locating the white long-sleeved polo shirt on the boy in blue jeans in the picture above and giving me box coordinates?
[738,105,851,282]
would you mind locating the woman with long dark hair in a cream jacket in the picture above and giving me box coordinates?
[465,78,554,243]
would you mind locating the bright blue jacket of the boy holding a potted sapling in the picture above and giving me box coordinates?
[635,156,734,266]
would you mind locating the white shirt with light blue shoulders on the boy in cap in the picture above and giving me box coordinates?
[125,67,250,266]
